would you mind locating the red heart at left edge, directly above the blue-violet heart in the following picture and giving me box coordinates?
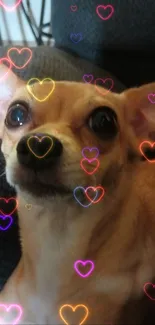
[0,197,18,217]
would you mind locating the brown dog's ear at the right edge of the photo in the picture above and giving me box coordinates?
[122,83,155,139]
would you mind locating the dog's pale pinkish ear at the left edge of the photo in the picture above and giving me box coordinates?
[0,64,24,139]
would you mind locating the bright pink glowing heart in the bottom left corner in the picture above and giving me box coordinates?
[0,304,23,325]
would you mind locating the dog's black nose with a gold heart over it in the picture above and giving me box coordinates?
[17,133,63,169]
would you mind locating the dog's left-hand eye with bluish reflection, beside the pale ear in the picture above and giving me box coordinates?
[5,103,30,128]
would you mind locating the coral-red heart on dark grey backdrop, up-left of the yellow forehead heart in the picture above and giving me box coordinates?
[7,47,32,69]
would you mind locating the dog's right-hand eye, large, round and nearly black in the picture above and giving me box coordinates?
[88,106,118,140]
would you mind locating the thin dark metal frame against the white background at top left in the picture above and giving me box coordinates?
[0,0,53,46]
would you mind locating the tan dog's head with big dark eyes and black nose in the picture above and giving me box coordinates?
[0,66,155,200]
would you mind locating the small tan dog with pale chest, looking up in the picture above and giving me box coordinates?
[0,66,155,325]
